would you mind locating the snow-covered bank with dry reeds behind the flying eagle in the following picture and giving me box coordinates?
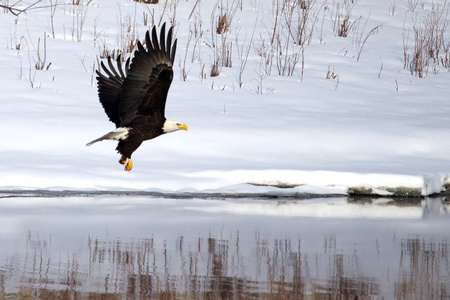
[0,0,450,194]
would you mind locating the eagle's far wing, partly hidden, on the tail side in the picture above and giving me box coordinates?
[96,55,130,127]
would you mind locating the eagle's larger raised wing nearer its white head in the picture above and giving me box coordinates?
[118,24,177,127]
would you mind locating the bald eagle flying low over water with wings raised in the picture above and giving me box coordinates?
[86,24,187,171]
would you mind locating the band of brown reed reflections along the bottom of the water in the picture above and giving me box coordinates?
[0,231,450,299]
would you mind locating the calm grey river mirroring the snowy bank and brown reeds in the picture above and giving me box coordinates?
[0,193,450,299]
